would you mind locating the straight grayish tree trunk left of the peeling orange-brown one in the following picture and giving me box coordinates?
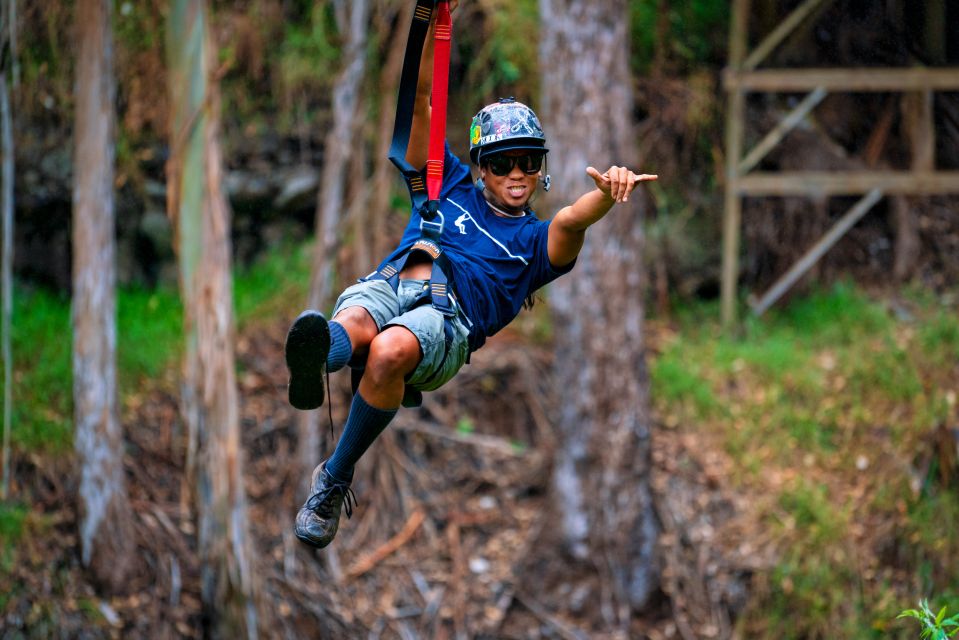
[73,0,134,592]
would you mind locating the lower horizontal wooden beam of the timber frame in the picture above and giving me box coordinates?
[737,171,959,196]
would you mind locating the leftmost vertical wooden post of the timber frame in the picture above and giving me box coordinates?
[720,0,749,327]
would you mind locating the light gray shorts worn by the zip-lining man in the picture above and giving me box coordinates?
[333,280,469,391]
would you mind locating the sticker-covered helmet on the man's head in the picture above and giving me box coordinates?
[470,98,549,164]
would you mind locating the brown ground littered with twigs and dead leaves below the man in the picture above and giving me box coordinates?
[0,321,772,639]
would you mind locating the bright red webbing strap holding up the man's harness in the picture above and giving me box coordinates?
[426,0,453,206]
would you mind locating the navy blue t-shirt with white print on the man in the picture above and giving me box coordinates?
[379,144,574,351]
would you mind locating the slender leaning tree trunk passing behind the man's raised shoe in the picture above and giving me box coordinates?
[299,0,370,478]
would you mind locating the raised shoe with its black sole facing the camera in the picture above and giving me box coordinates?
[286,310,330,411]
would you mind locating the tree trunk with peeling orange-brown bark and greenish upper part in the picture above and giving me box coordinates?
[167,0,257,638]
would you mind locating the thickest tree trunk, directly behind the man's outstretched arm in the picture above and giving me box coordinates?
[540,0,658,628]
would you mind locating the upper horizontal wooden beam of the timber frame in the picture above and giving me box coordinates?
[723,67,959,93]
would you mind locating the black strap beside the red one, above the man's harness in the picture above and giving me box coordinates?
[389,0,436,215]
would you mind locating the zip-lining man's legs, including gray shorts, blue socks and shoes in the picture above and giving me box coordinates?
[286,270,469,548]
